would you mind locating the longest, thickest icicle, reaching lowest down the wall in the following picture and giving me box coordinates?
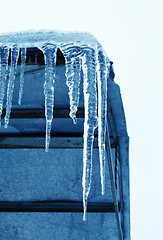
[82,48,97,221]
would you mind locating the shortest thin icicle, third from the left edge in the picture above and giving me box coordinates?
[18,48,26,105]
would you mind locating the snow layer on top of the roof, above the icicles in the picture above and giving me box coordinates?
[0,30,100,47]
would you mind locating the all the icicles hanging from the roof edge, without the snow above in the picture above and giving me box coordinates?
[0,40,109,221]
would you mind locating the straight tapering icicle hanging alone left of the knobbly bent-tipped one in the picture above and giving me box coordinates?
[42,44,57,152]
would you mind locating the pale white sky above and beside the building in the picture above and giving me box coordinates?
[0,0,163,240]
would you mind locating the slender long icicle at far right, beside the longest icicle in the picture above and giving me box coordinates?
[97,50,107,195]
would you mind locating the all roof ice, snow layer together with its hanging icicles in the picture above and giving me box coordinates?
[0,31,114,221]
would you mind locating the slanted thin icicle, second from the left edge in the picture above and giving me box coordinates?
[5,45,19,128]
